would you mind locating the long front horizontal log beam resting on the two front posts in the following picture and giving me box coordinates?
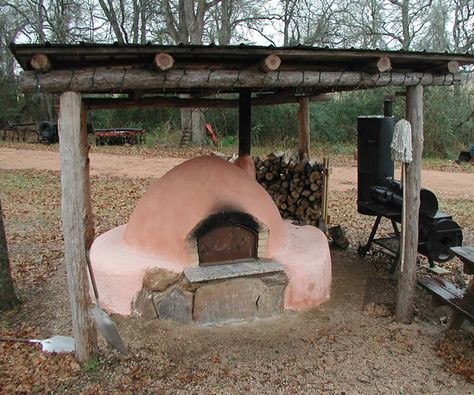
[21,69,461,93]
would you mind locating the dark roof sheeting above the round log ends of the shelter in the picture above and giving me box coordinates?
[10,43,474,72]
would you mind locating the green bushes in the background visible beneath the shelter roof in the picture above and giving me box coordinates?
[68,87,474,157]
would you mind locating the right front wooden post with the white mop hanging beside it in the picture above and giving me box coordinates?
[395,85,423,323]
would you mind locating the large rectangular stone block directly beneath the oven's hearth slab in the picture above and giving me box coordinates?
[193,277,286,324]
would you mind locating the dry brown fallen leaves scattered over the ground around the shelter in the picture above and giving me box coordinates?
[0,147,474,393]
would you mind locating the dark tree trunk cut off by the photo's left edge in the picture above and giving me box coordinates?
[0,201,20,311]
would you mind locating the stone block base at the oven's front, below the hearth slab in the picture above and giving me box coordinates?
[133,265,288,325]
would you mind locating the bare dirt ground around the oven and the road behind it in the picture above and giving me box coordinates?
[0,146,474,394]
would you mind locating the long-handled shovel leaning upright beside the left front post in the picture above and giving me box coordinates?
[86,252,128,355]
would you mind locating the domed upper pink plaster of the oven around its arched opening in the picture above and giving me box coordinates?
[124,155,286,265]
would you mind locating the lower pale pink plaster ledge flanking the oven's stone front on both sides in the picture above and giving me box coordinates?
[91,222,331,315]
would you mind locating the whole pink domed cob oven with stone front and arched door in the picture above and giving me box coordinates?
[91,156,331,325]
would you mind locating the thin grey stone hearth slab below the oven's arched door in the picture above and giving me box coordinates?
[184,259,285,283]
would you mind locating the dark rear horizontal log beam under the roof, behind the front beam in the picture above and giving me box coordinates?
[84,94,330,110]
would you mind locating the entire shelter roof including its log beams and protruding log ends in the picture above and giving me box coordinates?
[10,43,474,108]
